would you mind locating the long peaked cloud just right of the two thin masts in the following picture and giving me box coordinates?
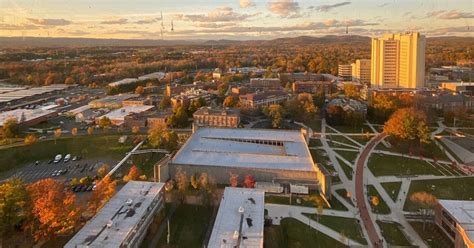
[181,7,260,22]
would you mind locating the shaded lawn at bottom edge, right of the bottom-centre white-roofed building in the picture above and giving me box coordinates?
[263,218,347,248]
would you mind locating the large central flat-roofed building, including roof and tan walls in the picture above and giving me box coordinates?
[169,128,329,194]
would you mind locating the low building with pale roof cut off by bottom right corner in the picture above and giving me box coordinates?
[435,200,474,248]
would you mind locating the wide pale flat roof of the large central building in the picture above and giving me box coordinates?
[172,128,315,172]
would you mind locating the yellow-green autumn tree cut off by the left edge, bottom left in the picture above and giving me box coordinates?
[0,179,31,234]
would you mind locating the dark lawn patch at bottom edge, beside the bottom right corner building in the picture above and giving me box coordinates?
[410,222,454,248]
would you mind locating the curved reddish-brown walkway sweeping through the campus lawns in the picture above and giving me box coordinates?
[355,133,386,247]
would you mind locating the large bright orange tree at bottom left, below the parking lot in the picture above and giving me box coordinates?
[27,179,81,241]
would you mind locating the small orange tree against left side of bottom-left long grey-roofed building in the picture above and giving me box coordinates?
[88,176,117,214]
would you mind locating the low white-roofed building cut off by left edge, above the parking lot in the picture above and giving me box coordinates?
[0,109,58,127]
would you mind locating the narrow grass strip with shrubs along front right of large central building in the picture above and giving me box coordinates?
[265,194,347,211]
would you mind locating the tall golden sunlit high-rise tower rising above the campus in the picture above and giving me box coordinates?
[371,32,426,88]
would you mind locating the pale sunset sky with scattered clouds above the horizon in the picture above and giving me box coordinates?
[0,0,474,40]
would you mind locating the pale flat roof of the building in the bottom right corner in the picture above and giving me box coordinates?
[438,200,474,240]
